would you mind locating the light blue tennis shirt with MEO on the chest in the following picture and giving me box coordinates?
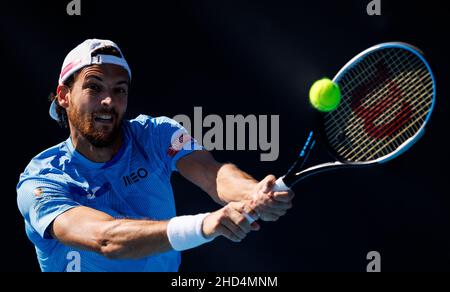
[17,115,202,271]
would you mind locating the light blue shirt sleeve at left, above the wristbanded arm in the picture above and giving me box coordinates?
[17,177,80,239]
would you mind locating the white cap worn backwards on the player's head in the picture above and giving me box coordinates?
[50,39,131,121]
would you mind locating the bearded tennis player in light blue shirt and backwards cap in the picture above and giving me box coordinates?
[17,39,293,271]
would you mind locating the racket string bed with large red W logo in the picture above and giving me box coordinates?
[325,49,433,161]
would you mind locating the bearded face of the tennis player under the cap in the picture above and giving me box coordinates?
[67,64,129,148]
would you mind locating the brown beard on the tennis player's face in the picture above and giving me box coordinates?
[67,109,122,148]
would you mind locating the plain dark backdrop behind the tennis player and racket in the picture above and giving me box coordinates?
[0,0,450,271]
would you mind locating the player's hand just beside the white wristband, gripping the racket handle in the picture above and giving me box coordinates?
[202,201,260,242]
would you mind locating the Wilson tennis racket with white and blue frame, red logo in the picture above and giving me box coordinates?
[245,43,436,222]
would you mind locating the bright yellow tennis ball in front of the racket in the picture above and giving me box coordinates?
[309,78,341,112]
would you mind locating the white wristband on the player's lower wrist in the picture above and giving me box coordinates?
[167,213,214,251]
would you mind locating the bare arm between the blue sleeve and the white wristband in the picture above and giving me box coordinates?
[50,207,171,258]
